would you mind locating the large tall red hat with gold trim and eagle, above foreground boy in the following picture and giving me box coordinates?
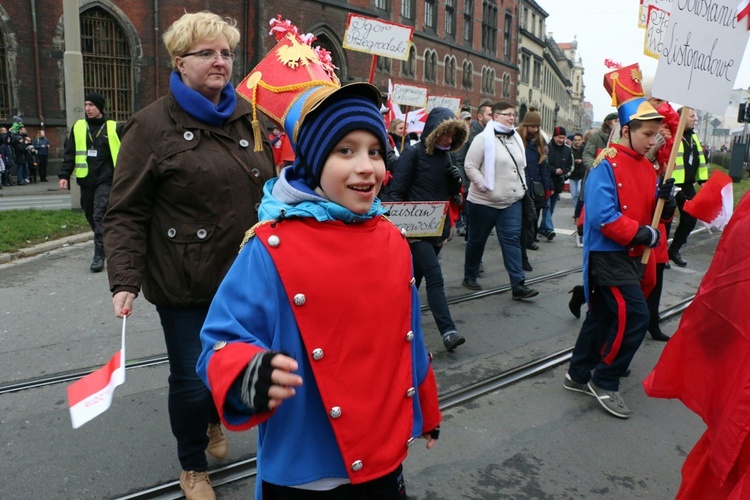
[237,15,381,150]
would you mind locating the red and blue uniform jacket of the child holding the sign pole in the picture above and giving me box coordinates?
[583,144,658,299]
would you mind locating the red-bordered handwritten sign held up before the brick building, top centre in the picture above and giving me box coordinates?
[344,14,414,61]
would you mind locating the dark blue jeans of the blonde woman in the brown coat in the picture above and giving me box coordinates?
[156,306,219,472]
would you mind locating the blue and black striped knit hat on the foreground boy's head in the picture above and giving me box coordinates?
[292,87,387,189]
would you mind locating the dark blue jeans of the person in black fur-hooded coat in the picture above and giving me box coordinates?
[409,241,456,335]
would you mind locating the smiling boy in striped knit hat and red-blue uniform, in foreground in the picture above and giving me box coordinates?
[197,18,441,499]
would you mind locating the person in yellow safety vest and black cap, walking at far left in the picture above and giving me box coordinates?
[57,92,120,273]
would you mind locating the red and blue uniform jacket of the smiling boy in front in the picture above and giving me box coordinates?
[197,175,441,498]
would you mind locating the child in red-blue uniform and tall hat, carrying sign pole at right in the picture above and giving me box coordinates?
[564,64,676,418]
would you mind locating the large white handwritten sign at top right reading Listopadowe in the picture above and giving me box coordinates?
[653,0,750,114]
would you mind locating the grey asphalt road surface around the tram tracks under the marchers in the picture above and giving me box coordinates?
[0,190,718,499]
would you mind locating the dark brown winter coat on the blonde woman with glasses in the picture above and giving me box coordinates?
[104,93,274,307]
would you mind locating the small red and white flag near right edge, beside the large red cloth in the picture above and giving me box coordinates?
[683,168,736,231]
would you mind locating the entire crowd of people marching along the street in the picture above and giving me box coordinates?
[0,12,724,499]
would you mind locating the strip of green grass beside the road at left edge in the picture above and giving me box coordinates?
[0,208,91,253]
